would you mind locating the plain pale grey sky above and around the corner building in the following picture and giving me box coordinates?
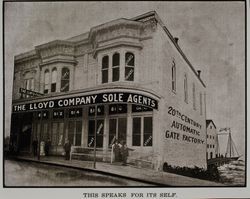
[4,1,245,155]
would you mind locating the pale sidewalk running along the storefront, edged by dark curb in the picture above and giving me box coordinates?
[13,156,225,187]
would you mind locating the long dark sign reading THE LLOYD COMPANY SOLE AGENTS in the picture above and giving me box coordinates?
[13,92,158,112]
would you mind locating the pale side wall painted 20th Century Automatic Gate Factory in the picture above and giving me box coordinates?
[154,26,206,168]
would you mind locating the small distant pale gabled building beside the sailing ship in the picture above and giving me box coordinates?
[206,120,218,159]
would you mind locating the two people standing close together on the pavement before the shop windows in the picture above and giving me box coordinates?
[111,140,129,165]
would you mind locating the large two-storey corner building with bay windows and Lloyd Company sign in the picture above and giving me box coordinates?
[11,12,206,169]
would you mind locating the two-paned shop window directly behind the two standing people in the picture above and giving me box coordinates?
[109,117,127,146]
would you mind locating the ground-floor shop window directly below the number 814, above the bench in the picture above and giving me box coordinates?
[68,121,82,146]
